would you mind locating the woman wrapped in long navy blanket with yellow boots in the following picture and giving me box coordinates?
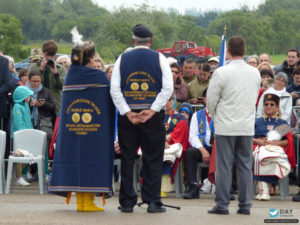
[49,29,115,211]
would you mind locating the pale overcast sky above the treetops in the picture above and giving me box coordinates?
[92,0,265,13]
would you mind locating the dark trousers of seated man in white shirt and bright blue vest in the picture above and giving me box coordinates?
[184,148,211,183]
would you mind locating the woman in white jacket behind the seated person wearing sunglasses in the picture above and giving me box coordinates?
[256,72,293,123]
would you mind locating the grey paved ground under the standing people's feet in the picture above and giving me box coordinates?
[0,183,300,225]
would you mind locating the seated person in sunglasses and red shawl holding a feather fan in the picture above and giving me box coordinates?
[253,93,296,201]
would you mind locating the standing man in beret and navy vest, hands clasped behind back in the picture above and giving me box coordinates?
[110,24,173,213]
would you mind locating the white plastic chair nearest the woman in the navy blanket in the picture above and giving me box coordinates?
[5,129,47,194]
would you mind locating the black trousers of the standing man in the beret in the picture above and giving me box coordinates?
[118,111,166,207]
